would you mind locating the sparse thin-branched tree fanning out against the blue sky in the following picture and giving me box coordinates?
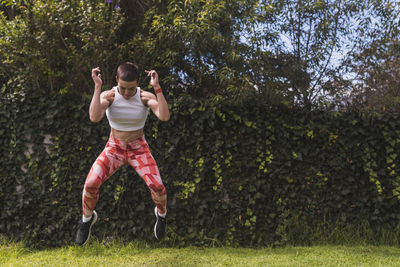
[250,0,363,107]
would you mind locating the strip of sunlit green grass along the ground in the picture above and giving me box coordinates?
[0,242,400,267]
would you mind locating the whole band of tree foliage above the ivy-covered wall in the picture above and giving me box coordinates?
[0,0,400,109]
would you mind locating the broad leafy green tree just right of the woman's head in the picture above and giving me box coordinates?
[125,0,307,102]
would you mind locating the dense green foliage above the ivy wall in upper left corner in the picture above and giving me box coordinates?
[0,0,126,93]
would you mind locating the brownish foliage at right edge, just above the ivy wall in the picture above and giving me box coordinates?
[335,40,400,112]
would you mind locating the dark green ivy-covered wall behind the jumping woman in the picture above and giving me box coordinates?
[0,95,400,246]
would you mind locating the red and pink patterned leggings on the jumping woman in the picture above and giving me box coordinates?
[82,135,167,217]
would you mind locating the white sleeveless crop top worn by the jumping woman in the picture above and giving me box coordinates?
[106,86,149,131]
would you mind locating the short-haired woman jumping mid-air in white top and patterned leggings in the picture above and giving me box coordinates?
[76,62,170,245]
